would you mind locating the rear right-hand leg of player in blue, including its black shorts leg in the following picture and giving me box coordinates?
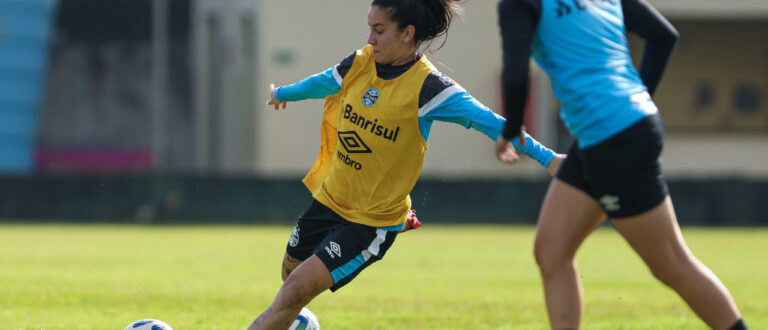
[583,116,740,329]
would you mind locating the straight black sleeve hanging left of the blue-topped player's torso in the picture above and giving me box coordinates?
[498,0,541,140]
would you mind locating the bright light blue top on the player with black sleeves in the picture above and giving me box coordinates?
[533,0,658,148]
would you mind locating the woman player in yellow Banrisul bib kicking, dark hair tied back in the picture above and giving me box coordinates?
[249,0,564,329]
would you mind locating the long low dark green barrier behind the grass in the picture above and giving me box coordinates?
[0,174,768,226]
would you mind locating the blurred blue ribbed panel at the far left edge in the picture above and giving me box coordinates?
[0,0,55,173]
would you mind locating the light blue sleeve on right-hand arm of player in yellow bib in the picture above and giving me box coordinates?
[419,76,555,167]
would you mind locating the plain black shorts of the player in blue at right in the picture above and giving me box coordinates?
[557,115,669,218]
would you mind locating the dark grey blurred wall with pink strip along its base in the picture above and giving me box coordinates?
[35,0,194,173]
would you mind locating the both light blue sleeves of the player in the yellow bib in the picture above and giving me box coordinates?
[275,67,555,167]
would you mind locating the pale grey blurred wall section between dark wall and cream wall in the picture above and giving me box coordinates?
[192,0,261,173]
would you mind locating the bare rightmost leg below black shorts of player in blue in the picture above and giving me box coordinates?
[613,196,741,329]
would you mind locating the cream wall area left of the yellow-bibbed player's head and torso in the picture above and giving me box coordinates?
[256,0,367,176]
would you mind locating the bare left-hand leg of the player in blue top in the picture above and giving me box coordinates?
[534,179,605,329]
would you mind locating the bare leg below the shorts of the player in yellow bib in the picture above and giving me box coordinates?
[248,255,333,330]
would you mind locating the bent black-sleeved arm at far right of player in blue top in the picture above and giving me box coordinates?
[621,0,678,95]
